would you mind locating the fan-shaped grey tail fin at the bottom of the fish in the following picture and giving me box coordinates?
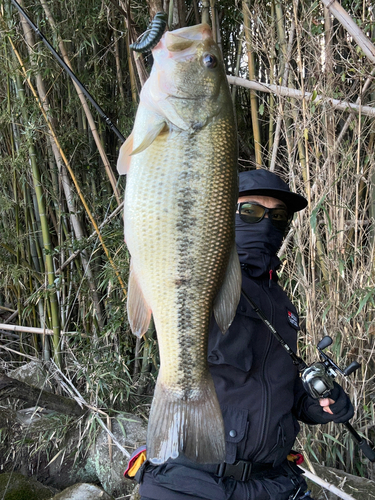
[147,376,225,464]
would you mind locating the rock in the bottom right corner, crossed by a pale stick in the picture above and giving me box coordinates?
[307,464,375,500]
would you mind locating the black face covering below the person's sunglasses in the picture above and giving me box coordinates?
[236,214,284,278]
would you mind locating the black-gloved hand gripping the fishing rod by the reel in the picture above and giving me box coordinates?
[304,382,354,424]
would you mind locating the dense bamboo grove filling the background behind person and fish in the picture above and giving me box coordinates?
[0,0,375,478]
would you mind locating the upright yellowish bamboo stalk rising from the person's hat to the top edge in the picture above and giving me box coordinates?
[242,0,262,168]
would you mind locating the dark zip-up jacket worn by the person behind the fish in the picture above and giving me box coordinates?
[208,271,312,466]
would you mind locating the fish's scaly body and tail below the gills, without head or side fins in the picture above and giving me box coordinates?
[124,119,237,463]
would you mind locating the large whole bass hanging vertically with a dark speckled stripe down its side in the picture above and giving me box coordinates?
[117,24,241,464]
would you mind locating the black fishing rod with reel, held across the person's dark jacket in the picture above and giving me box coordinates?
[241,289,375,462]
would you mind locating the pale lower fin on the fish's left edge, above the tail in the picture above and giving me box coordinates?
[127,265,151,337]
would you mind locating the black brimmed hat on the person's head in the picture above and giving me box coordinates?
[239,168,307,212]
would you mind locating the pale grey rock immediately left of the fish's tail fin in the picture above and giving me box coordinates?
[86,414,147,496]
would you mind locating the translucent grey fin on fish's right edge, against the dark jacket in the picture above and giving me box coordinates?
[214,244,242,334]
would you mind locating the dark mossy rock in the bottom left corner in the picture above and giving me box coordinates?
[0,472,53,500]
